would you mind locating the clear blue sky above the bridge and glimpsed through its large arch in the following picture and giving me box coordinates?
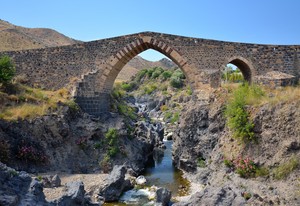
[0,0,300,60]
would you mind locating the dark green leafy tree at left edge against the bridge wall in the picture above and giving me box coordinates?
[0,56,16,84]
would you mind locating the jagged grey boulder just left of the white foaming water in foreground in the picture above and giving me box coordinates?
[99,165,131,202]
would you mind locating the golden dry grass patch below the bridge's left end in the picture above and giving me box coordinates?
[0,85,69,121]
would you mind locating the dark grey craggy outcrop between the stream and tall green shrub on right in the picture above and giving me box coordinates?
[173,104,225,172]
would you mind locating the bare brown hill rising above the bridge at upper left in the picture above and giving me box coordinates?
[0,20,80,51]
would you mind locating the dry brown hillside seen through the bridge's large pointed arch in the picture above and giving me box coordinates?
[117,56,177,81]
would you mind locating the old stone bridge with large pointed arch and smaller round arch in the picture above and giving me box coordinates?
[1,32,300,115]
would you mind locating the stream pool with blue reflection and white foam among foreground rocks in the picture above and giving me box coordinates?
[104,141,189,206]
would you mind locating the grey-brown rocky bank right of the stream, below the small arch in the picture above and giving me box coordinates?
[173,97,300,205]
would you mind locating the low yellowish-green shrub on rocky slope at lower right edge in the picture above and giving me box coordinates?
[273,156,300,180]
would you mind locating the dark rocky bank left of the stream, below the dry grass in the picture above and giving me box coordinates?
[0,106,162,175]
